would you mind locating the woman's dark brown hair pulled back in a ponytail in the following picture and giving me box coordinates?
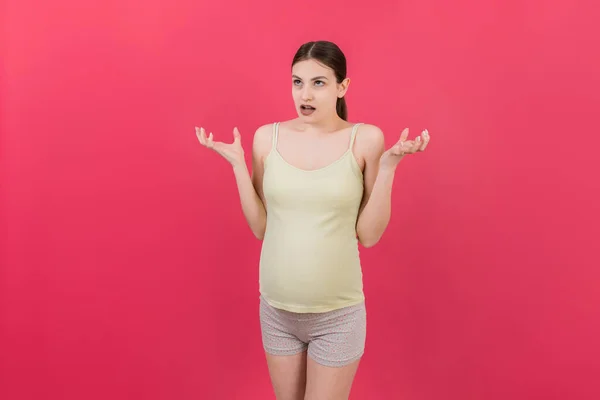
[292,40,348,121]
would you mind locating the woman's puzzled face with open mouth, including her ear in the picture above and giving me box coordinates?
[292,60,349,121]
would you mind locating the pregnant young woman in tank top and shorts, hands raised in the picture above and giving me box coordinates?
[196,41,429,400]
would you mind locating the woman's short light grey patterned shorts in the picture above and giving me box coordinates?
[260,296,367,367]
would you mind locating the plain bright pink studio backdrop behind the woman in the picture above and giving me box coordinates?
[0,0,600,400]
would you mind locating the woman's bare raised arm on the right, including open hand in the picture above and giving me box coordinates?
[356,125,429,247]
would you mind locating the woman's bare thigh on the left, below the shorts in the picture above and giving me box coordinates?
[266,351,306,400]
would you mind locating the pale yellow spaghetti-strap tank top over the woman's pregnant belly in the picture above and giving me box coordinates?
[259,123,364,313]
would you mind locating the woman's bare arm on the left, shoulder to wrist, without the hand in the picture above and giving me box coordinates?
[233,125,271,240]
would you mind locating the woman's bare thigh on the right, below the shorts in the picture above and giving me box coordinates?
[305,357,360,400]
